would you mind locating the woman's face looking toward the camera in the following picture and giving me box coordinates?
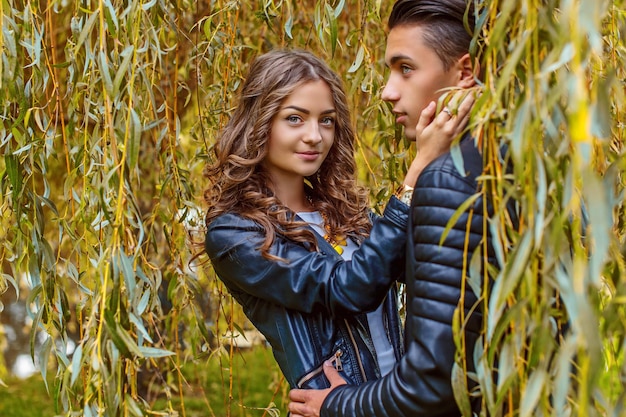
[264,80,337,183]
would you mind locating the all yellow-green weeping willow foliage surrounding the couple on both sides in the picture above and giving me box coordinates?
[0,0,626,416]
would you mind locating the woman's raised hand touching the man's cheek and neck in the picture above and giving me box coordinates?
[404,90,475,187]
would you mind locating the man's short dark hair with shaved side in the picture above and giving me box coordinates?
[388,0,475,71]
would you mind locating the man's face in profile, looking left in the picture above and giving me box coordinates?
[382,25,460,141]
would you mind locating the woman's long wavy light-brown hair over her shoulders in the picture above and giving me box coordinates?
[204,50,371,259]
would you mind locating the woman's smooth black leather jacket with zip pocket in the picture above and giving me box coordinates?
[205,197,408,388]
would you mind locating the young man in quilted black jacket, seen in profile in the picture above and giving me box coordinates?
[289,0,487,417]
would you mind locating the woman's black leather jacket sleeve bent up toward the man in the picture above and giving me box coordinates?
[205,197,408,317]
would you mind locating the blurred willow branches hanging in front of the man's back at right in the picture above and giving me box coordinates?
[457,0,626,417]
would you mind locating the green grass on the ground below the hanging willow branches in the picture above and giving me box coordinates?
[0,347,289,417]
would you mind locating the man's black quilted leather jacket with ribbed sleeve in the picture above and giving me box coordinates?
[321,138,491,417]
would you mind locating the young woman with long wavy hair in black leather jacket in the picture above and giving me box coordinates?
[205,50,466,388]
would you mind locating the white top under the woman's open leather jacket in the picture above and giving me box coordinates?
[297,211,396,376]
